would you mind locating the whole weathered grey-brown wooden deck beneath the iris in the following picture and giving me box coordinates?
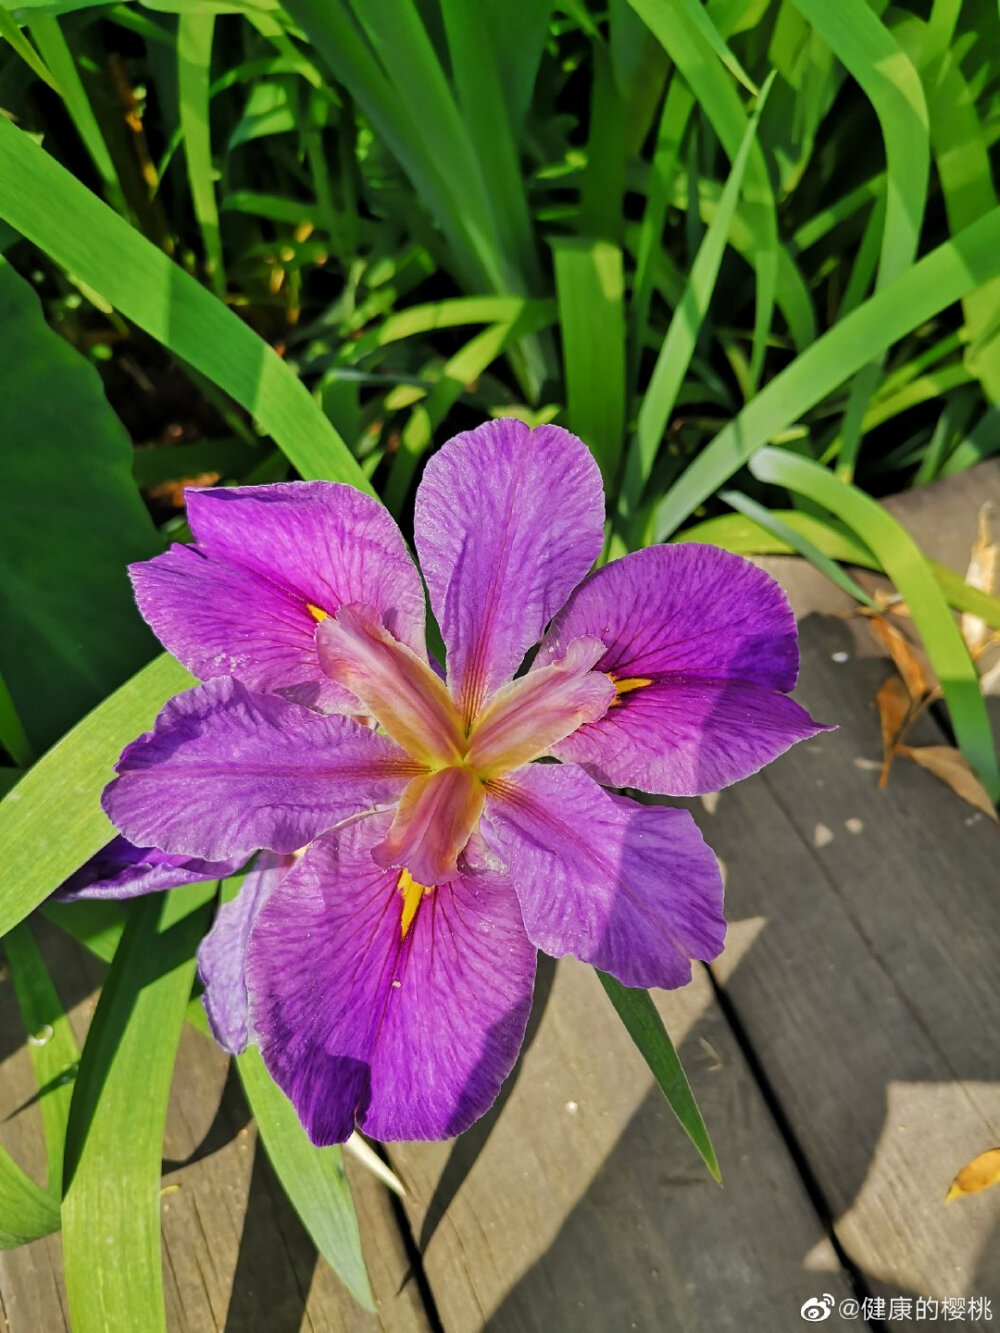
[0,463,1000,1333]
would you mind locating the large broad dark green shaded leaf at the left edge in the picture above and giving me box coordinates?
[0,259,161,750]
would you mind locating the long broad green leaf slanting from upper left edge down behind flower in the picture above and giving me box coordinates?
[0,116,373,493]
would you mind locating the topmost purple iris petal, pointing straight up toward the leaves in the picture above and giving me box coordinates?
[413,420,604,721]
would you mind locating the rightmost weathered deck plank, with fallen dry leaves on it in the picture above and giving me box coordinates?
[701,469,1000,1328]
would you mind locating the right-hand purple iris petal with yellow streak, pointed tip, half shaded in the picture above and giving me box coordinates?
[536,543,825,796]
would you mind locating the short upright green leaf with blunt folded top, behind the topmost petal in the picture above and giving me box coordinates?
[552,237,625,489]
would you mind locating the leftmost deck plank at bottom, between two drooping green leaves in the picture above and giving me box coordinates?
[163,1029,427,1333]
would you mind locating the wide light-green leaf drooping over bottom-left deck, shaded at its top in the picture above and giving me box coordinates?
[63,884,216,1333]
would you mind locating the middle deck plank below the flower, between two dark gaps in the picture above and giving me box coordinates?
[392,949,851,1333]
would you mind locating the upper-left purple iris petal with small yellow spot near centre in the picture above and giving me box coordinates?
[131,481,425,712]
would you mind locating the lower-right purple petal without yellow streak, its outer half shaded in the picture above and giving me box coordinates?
[481,764,725,988]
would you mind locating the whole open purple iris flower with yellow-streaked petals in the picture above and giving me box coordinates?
[104,420,823,1144]
